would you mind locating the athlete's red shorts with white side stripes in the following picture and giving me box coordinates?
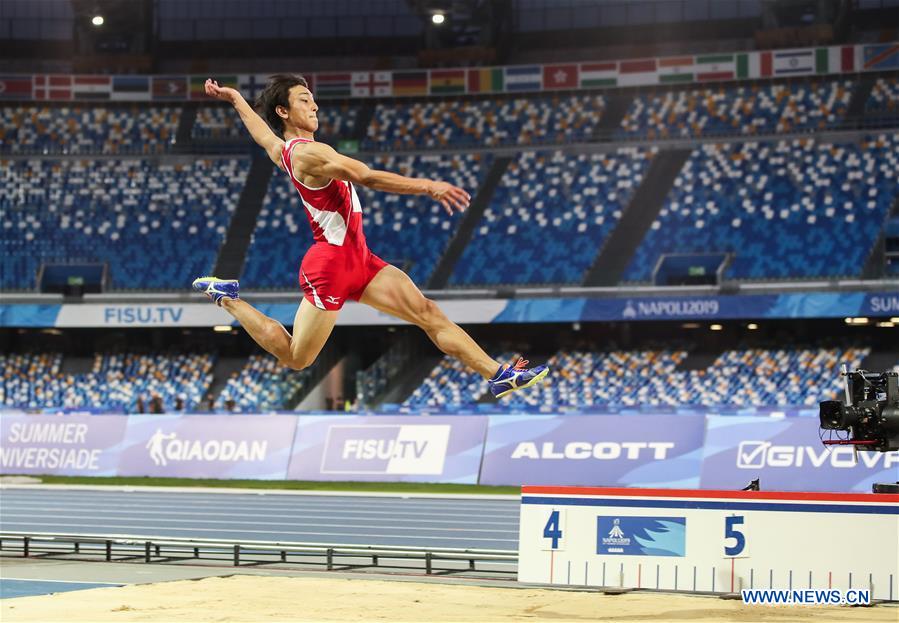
[299,242,387,311]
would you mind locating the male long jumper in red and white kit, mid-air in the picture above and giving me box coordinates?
[193,75,549,397]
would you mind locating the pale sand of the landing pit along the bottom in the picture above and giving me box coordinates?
[0,576,899,623]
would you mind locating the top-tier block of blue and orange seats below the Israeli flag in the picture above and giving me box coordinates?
[617,80,852,139]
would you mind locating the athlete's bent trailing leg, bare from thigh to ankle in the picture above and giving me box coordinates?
[221,298,339,370]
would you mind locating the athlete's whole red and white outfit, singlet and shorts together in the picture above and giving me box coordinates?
[281,138,387,310]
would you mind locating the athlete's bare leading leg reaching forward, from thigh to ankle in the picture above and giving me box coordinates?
[359,265,500,379]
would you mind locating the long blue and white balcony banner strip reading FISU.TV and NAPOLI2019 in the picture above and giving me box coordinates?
[0,291,899,328]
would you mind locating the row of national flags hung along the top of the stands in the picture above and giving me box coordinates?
[0,43,899,101]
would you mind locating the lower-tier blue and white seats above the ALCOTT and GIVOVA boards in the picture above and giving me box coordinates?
[404,346,870,411]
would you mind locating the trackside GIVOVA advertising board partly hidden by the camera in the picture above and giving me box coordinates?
[699,417,899,493]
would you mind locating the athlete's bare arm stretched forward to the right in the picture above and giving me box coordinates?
[291,143,471,214]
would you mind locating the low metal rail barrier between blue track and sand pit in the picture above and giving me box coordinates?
[0,532,518,575]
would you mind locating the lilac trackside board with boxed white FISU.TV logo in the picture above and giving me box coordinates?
[287,415,487,484]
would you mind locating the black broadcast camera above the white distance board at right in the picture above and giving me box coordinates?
[819,364,899,452]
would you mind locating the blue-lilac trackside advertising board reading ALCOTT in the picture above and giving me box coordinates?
[481,415,705,488]
